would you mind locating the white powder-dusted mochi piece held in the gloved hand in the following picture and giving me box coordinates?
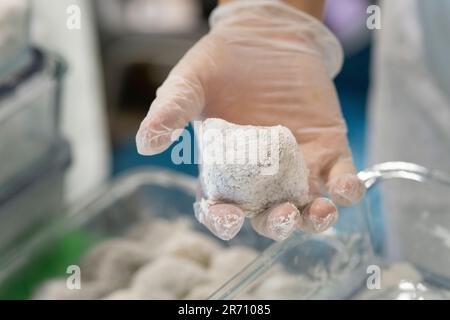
[199,119,308,217]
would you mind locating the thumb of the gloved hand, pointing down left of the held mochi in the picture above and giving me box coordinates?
[136,72,205,155]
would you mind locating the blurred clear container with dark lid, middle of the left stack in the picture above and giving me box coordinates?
[0,50,65,186]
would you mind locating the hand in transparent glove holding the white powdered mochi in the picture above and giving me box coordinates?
[136,0,365,240]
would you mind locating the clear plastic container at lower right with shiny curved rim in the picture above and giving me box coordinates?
[211,162,450,299]
